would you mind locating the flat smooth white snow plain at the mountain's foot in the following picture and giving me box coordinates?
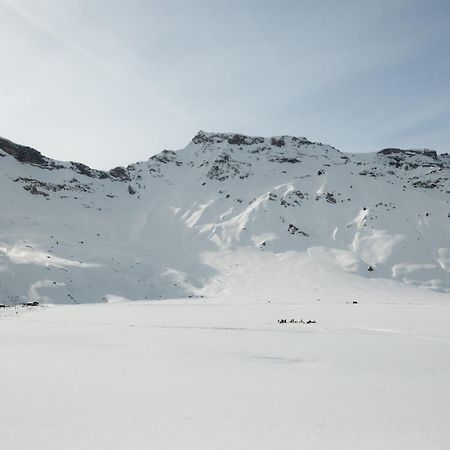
[0,289,450,450]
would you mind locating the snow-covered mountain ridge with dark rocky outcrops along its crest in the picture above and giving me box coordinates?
[0,131,450,303]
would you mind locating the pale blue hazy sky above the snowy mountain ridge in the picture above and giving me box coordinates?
[0,0,450,169]
